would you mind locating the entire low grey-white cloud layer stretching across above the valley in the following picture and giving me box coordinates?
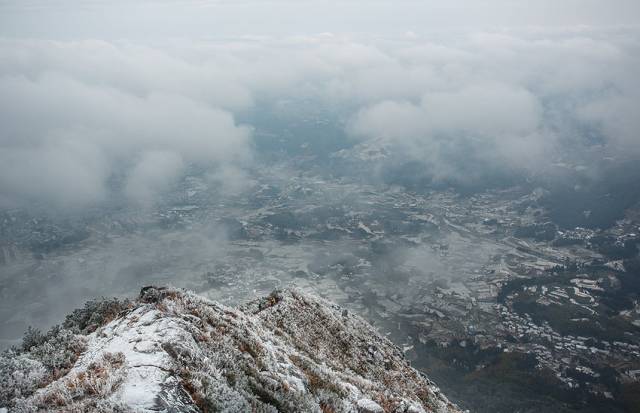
[0,19,640,206]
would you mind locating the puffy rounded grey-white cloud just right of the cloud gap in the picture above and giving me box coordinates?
[350,83,553,180]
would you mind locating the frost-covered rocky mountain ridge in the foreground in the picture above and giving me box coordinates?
[0,287,458,413]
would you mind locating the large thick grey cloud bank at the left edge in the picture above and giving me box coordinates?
[0,42,252,207]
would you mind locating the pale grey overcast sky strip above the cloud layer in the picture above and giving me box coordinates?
[0,0,640,39]
